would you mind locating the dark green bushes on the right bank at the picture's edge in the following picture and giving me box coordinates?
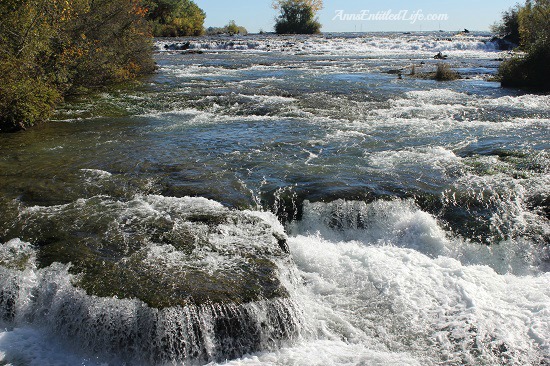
[499,0,550,91]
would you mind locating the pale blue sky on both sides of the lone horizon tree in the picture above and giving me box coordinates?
[195,0,523,33]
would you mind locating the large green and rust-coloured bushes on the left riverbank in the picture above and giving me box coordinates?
[0,0,154,131]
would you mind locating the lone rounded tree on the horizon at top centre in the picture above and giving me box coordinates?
[273,0,323,34]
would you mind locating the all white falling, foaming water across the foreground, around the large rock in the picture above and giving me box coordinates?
[0,197,550,366]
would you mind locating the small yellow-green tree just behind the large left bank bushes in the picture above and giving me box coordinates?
[148,0,206,37]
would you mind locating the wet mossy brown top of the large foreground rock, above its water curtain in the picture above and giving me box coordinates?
[3,196,289,309]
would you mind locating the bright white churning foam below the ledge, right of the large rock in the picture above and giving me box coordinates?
[291,233,550,365]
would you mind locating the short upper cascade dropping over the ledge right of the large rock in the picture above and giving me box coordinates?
[292,200,549,275]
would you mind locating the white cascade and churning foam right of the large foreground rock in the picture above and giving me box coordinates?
[206,197,550,366]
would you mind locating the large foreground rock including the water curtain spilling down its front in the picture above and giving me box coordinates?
[0,196,301,365]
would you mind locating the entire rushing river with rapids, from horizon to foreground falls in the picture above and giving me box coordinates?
[0,33,550,365]
